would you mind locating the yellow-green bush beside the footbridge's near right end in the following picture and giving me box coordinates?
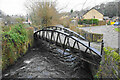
[95,48,120,80]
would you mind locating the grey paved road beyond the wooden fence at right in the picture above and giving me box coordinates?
[80,25,119,48]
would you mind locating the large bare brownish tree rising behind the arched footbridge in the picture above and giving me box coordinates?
[26,0,60,27]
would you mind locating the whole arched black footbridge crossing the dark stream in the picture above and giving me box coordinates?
[34,25,104,65]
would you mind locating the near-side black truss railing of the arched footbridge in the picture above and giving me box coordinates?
[34,27,103,57]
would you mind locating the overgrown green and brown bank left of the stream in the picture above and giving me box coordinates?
[2,24,33,70]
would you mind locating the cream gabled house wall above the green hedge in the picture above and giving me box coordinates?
[82,9,103,21]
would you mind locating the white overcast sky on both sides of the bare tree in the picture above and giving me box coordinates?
[0,0,114,15]
